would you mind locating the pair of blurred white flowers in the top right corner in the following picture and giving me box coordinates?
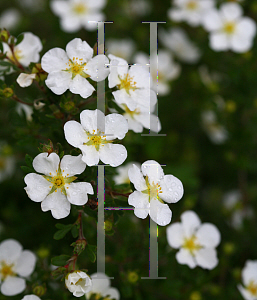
[168,0,256,53]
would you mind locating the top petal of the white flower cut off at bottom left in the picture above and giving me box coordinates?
[0,239,22,264]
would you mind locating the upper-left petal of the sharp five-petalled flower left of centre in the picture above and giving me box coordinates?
[33,152,60,176]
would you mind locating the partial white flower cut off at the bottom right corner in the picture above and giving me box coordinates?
[238,260,257,300]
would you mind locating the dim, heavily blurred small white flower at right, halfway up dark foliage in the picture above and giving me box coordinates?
[202,110,228,144]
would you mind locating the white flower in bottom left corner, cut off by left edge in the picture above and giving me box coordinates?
[0,239,36,296]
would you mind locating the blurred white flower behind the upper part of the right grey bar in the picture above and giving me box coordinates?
[134,50,180,95]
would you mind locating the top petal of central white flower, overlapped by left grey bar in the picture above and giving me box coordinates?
[80,109,105,134]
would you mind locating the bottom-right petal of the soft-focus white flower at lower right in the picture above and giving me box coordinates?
[195,248,219,270]
